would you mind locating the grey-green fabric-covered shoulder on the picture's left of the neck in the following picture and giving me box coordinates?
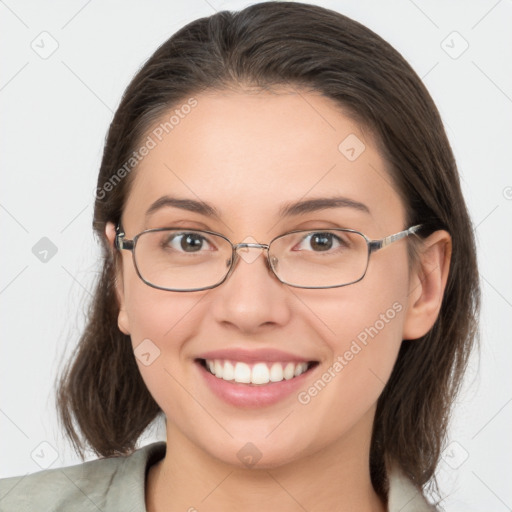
[0,441,166,512]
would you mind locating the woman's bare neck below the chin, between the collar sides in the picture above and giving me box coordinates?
[146,412,386,512]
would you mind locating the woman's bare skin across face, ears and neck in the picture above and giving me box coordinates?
[106,89,450,512]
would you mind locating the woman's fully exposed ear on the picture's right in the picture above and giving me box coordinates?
[403,230,452,340]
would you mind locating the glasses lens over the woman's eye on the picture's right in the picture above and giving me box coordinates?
[270,229,368,288]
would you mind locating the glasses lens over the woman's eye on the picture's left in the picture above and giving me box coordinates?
[134,229,232,291]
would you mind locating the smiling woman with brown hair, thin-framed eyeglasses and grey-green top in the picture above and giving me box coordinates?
[0,2,479,512]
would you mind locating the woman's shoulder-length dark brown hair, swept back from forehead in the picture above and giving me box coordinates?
[57,2,480,504]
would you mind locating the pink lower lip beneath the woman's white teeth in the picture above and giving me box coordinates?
[196,361,317,408]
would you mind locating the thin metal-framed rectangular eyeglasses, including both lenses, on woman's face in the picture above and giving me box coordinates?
[115,224,422,292]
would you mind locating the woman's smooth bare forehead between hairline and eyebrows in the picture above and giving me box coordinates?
[124,89,403,232]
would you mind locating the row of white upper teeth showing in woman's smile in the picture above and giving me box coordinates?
[196,358,319,386]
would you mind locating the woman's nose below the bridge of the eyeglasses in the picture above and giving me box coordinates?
[207,243,292,334]
